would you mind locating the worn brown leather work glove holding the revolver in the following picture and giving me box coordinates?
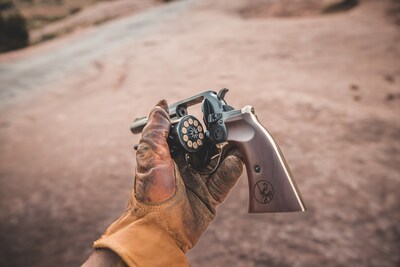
[94,100,243,266]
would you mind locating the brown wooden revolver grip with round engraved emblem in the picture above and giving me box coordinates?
[225,106,306,213]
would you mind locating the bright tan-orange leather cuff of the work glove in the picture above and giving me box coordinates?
[93,165,189,267]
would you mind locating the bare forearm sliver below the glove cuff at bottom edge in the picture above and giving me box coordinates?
[82,249,127,267]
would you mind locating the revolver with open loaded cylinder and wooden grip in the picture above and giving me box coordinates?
[131,88,306,213]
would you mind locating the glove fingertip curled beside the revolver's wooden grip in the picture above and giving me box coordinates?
[207,149,243,203]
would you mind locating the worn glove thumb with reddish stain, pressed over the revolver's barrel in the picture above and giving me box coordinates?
[135,100,175,203]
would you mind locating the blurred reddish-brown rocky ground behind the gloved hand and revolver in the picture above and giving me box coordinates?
[0,0,400,267]
